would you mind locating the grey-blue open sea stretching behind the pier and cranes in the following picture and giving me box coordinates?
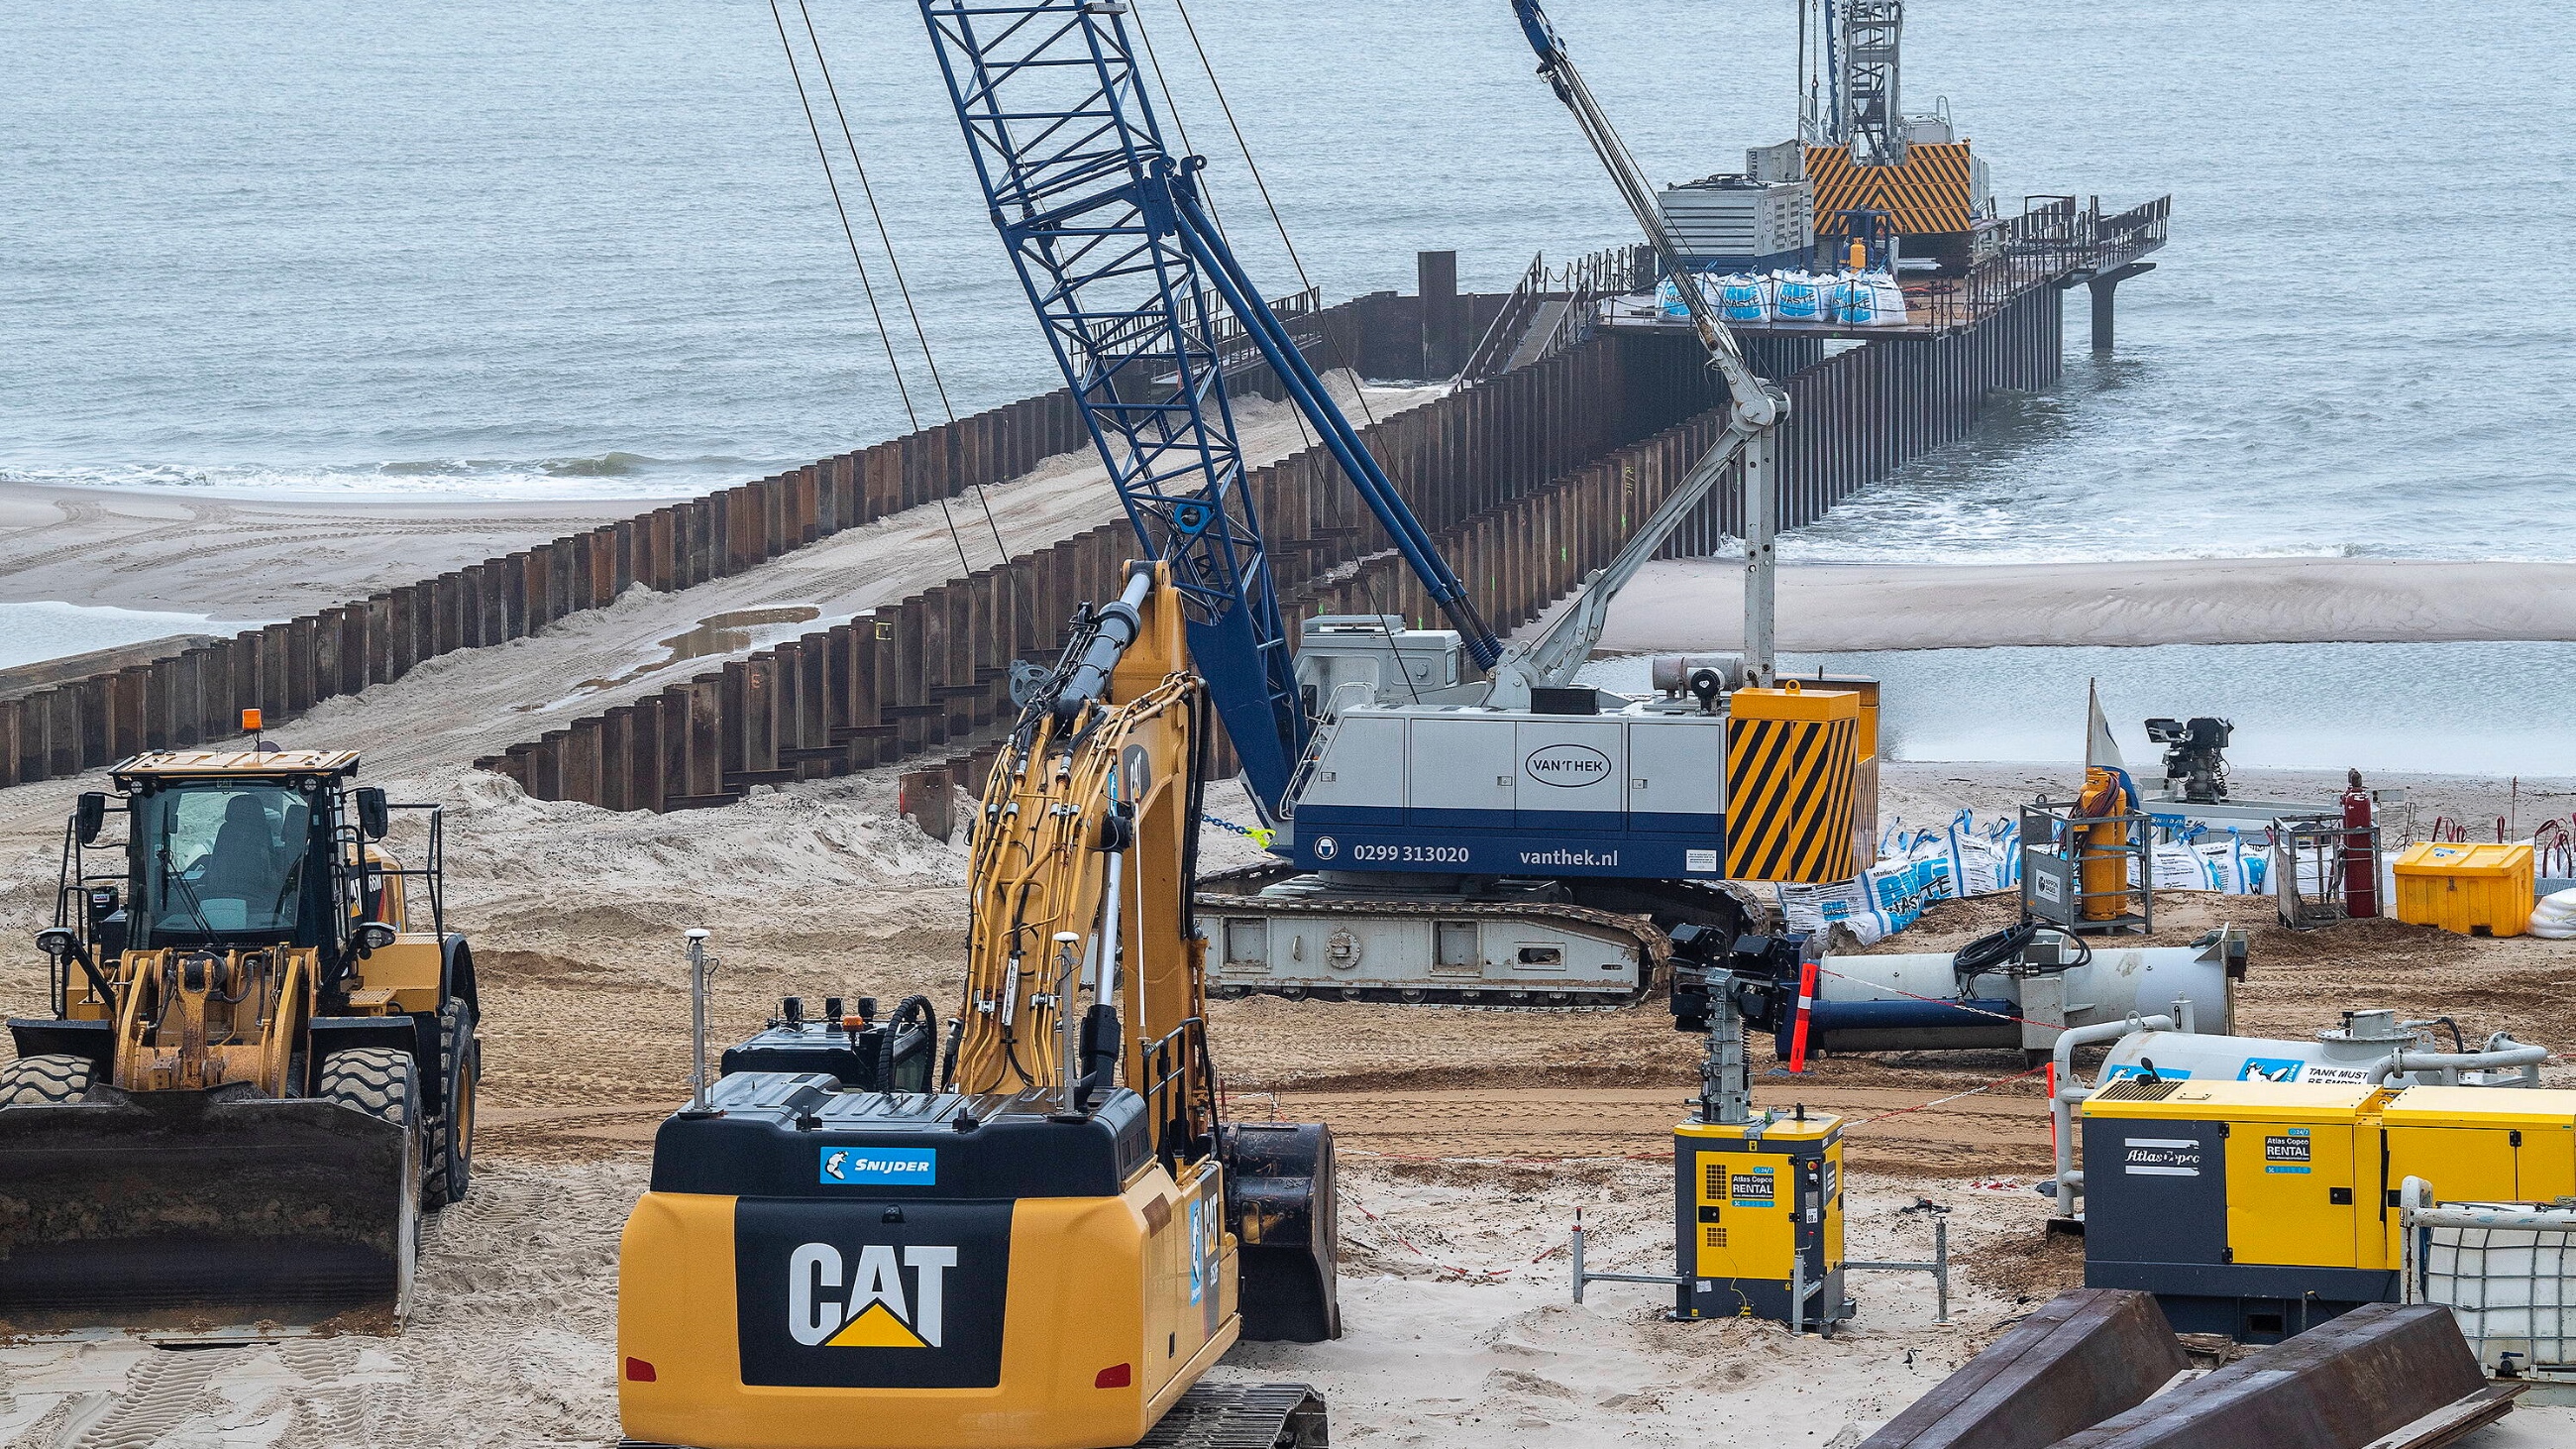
[0,0,2576,560]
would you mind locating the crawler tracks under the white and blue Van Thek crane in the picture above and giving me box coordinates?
[1190,861,1744,1011]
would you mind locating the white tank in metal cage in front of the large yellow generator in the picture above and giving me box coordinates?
[2399,1178,2576,1382]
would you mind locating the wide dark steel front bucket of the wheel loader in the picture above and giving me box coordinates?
[0,1093,420,1341]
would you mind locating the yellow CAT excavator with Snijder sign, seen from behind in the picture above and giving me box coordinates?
[618,565,1340,1449]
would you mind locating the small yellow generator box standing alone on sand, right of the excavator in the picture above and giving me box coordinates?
[1671,1111,1845,1325]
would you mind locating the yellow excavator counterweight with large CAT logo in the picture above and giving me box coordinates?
[618,1139,1239,1449]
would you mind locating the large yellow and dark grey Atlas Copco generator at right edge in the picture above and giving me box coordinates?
[2084,1077,2576,1343]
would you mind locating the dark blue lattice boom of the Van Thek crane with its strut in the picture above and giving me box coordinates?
[919,0,1502,818]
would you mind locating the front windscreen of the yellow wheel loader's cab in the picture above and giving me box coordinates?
[132,781,306,947]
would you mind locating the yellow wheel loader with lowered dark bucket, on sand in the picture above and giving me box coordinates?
[0,712,482,1341]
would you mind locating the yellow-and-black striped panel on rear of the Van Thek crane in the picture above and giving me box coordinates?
[1726,720,1860,884]
